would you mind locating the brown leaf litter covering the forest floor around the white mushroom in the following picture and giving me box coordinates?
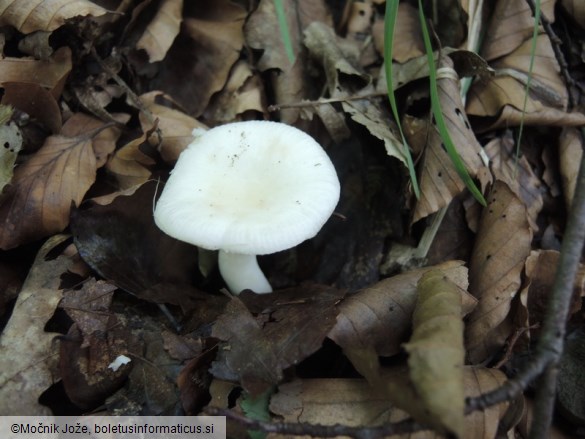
[0,0,585,437]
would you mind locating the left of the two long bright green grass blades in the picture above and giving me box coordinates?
[384,0,420,200]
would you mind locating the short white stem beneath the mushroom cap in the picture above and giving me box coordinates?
[219,250,272,295]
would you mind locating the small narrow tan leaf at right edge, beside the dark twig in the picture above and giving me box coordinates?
[559,128,583,212]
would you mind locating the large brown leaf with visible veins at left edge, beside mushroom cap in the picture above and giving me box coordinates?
[0,113,119,249]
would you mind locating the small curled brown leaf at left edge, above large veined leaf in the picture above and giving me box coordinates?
[0,47,72,95]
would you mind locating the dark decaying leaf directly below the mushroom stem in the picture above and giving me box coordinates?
[211,285,343,395]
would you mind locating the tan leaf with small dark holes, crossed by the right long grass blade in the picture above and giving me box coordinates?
[407,57,483,223]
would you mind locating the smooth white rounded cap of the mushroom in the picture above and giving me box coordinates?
[154,121,340,255]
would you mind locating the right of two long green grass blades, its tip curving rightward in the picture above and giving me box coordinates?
[418,0,486,206]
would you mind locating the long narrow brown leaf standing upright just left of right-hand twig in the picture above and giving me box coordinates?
[465,180,532,363]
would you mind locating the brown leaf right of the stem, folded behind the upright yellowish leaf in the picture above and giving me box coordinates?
[328,261,475,356]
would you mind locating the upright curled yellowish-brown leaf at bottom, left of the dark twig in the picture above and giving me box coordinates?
[403,270,465,437]
